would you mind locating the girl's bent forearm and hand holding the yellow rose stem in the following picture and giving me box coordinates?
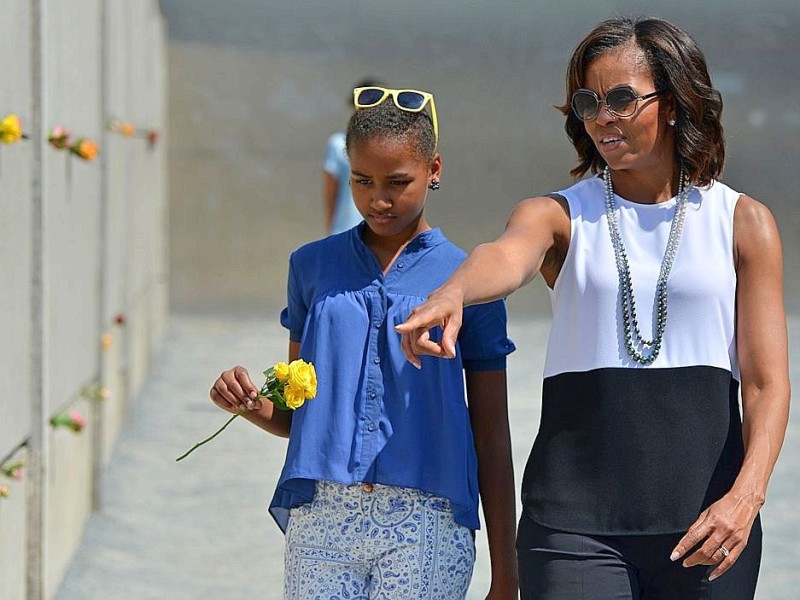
[211,342,300,437]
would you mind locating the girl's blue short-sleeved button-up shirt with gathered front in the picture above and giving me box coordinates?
[270,223,514,529]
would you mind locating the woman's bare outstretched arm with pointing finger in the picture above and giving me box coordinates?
[396,197,570,368]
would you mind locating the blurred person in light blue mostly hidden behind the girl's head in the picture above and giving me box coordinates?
[322,79,382,235]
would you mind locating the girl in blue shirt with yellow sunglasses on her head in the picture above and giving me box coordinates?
[211,87,517,600]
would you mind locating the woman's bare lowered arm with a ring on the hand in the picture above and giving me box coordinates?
[673,196,790,578]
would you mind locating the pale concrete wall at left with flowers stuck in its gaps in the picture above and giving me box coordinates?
[0,0,168,600]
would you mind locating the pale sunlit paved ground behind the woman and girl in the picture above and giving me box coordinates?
[56,316,800,600]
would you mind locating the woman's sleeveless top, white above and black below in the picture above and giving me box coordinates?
[522,177,743,535]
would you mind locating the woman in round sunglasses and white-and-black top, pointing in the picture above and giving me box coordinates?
[397,18,789,600]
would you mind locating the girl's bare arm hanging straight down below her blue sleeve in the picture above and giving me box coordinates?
[466,371,519,600]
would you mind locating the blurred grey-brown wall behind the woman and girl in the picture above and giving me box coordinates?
[161,0,800,322]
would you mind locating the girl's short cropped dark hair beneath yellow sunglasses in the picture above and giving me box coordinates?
[345,98,436,160]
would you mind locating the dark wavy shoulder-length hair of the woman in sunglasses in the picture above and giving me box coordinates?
[557,17,725,186]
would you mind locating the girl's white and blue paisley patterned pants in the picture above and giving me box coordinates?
[284,482,475,600]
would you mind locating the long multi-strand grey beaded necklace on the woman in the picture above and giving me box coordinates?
[603,167,689,365]
